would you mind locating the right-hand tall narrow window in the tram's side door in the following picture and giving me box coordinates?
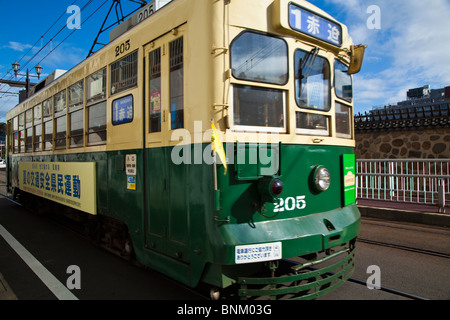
[169,37,184,130]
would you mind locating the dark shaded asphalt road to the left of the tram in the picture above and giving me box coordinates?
[0,197,204,300]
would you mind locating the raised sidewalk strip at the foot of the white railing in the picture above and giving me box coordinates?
[357,199,450,227]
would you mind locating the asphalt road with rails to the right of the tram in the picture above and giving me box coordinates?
[321,218,450,300]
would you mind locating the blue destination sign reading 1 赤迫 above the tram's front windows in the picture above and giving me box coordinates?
[288,3,342,46]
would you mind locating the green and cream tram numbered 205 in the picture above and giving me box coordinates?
[7,0,364,298]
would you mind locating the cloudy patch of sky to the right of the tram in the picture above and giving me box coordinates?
[325,0,450,112]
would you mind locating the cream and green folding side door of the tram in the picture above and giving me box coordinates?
[144,27,189,262]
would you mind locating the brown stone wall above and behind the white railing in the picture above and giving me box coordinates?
[356,127,450,159]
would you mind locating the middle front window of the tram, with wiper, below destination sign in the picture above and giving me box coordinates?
[294,50,331,111]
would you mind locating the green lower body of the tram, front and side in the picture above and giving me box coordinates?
[8,143,360,296]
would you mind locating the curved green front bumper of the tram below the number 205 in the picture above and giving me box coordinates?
[216,204,360,265]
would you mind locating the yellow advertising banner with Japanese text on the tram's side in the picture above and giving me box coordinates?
[19,162,97,215]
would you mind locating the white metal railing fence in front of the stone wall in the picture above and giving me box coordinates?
[357,159,450,211]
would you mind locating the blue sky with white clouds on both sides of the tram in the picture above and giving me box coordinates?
[0,0,450,122]
